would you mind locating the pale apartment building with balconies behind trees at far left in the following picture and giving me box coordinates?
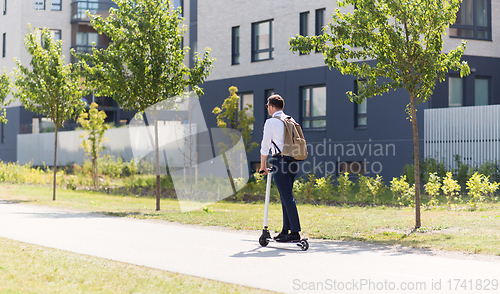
[0,0,176,161]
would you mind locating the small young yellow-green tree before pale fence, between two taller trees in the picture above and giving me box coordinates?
[77,102,109,189]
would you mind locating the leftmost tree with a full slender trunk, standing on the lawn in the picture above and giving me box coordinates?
[14,28,85,200]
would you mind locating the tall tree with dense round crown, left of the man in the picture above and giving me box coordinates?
[78,0,213,210]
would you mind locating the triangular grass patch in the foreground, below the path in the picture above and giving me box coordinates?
[0,238,271,294]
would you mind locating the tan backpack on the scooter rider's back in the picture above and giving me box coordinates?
[273,116,307,161]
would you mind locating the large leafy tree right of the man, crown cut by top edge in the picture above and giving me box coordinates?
[289,0,470,228]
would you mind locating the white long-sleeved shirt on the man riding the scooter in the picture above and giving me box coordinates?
[260,110,287,156]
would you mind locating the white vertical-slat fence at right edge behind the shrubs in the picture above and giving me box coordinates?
[424,105,500,168]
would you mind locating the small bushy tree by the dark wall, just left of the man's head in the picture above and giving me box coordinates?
[212,86,259,152]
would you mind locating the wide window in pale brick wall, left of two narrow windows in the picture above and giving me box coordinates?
[252,20,274,62]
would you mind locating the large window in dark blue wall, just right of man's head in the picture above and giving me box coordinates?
[302,86,326,129]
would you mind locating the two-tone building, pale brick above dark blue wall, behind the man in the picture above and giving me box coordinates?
[195,0,500,180]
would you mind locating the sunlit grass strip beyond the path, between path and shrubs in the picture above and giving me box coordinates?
[0,184,500,255]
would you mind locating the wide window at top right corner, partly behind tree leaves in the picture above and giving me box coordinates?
[450,0,491,40]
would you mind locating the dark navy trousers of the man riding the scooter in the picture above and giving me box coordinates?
[271,155,301,232]
